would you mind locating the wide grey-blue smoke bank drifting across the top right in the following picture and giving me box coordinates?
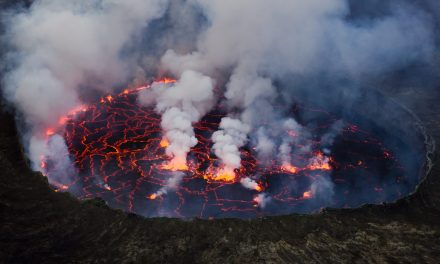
[173,0,432,76]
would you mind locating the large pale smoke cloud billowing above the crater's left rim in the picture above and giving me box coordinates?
[3,0,167,173]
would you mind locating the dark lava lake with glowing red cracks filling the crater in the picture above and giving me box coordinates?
[44,84,427,218]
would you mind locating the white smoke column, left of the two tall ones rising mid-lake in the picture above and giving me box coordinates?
[139,71,214,169]
